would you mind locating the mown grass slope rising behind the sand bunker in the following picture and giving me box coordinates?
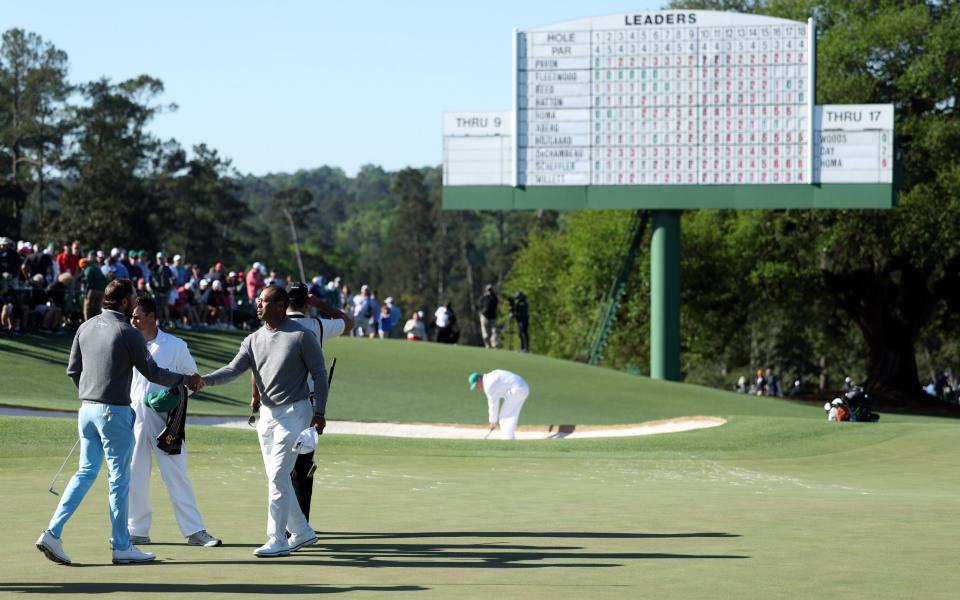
[0,333,823,424]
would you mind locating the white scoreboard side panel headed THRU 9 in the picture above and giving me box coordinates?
[443,111,515,186]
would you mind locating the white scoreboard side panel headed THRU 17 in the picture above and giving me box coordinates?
[813,104,893,183]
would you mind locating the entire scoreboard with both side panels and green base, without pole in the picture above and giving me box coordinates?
[444,11,893,209]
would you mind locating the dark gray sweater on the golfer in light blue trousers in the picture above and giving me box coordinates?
[67,310,186,406]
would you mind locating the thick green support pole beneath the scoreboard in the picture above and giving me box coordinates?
[650,210,680,381]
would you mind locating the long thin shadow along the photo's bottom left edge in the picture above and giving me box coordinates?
[0,582,430,596]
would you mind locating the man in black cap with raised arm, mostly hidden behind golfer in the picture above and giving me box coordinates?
[278,283,353,521]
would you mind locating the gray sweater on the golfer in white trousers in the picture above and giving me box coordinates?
[203,317,327,414]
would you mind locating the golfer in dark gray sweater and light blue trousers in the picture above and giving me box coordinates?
[37,279,203,565]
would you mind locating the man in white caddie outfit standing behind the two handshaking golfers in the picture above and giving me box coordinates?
[127,296,221,547]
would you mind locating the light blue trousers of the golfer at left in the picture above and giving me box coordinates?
[47,403,134,550]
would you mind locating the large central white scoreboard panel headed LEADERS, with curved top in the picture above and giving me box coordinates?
[515,11,813,186]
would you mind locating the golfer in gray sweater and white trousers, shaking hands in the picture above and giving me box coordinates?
[203,286,327,558]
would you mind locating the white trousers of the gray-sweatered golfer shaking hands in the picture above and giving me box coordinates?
[257,400,313,540]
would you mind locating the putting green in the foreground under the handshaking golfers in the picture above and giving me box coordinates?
[0,415,960,600]
